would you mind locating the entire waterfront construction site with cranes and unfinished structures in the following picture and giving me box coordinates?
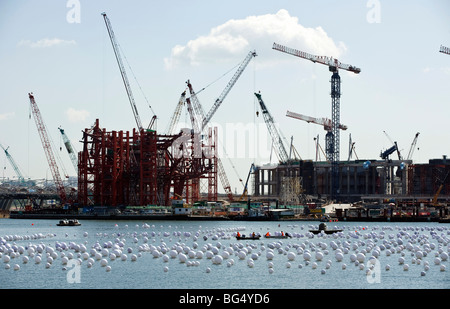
[0,13,450,221]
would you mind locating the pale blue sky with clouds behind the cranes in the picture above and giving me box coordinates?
[0,0,450,192]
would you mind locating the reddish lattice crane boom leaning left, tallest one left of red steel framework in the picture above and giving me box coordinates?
[28,92,67,204]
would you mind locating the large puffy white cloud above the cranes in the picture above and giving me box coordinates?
[164,9,347,69]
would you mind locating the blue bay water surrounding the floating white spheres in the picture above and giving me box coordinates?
[0,219,450,289]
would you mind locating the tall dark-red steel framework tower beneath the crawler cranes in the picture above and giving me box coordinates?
[78,120,217,206]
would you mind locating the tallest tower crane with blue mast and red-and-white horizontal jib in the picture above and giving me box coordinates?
[272,43,361,198]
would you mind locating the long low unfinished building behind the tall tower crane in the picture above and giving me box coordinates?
[254,156,450,204]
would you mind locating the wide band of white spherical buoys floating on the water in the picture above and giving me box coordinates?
[0,224,450,284]
